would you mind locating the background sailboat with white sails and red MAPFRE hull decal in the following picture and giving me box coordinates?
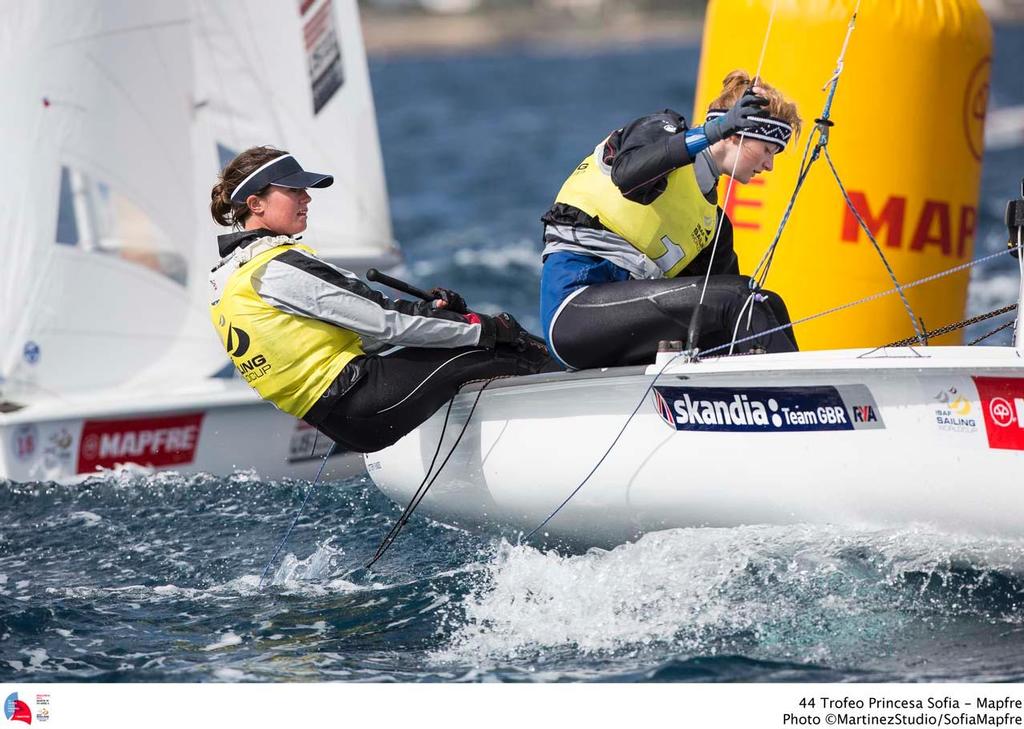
[0,0,399,481]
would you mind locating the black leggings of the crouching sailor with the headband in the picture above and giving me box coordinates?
[551,275,797,370]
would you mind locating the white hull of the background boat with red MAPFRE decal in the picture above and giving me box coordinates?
[0,379,362,482]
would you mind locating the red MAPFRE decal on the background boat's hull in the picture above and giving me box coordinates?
[78,413,203,473]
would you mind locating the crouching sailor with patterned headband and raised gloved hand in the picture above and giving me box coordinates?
[541,71,801,369]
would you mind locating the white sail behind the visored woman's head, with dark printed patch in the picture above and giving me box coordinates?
[193,0,397,268]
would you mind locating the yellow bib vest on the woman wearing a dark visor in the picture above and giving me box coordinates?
[210,245,364,418]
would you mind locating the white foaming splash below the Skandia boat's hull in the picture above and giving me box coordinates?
[433,526,1024,663]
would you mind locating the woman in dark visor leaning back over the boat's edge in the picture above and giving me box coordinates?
[202,146,550,453]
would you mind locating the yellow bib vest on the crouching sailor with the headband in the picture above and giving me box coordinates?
[555,142,718,278]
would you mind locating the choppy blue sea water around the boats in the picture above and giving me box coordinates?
[0,29,1024,682]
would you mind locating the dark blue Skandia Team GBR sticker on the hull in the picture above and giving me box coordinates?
[653,385,886,433]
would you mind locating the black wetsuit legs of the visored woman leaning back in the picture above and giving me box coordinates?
[312,347,556,453]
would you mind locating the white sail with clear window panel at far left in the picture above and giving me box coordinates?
[0,0,205,396]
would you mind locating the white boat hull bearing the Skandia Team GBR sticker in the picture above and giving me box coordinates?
[366,347,1024,546]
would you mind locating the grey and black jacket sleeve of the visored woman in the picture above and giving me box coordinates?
[252,250,481,348]
